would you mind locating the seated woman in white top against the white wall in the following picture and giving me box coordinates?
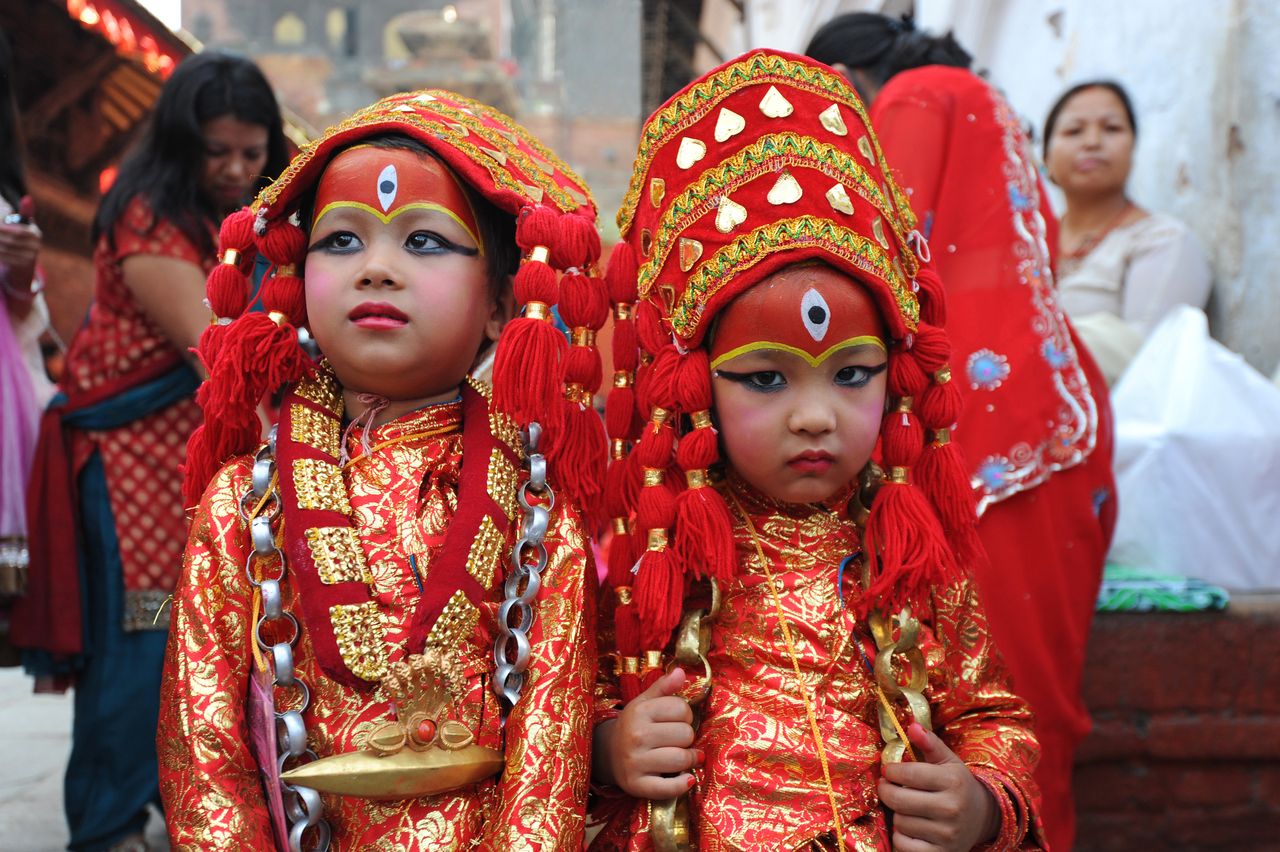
[1044,81,1212,383]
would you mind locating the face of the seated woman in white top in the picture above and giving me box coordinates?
[1046,87,1134,194]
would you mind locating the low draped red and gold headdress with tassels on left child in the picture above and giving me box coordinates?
[186,90,608,505]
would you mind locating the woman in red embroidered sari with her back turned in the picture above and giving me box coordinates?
[808,13,1115,849]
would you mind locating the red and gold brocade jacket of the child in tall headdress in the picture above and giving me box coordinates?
[593,473,1041,851]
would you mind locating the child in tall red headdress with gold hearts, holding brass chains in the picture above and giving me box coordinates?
[593,52,1039,851]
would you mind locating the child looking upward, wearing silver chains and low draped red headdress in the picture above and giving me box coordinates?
[157,91,608,849]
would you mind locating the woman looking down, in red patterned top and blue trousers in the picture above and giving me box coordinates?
[14,52,285,849]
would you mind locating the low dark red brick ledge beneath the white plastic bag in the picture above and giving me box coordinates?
[1075,595,1280,852]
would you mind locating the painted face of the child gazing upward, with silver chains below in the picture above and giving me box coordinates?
[303,146,504,400]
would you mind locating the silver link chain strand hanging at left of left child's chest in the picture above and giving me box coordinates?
[241,426,332,852]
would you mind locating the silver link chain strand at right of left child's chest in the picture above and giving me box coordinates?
[493,423,556,724]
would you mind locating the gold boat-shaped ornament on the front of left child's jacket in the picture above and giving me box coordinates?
[282,650,503,801]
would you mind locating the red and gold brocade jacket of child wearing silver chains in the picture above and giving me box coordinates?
[157,378,595,852]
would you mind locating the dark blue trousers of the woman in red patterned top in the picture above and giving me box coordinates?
[64,453,168,851]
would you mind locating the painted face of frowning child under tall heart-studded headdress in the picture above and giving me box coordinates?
[710,265,888,503]
